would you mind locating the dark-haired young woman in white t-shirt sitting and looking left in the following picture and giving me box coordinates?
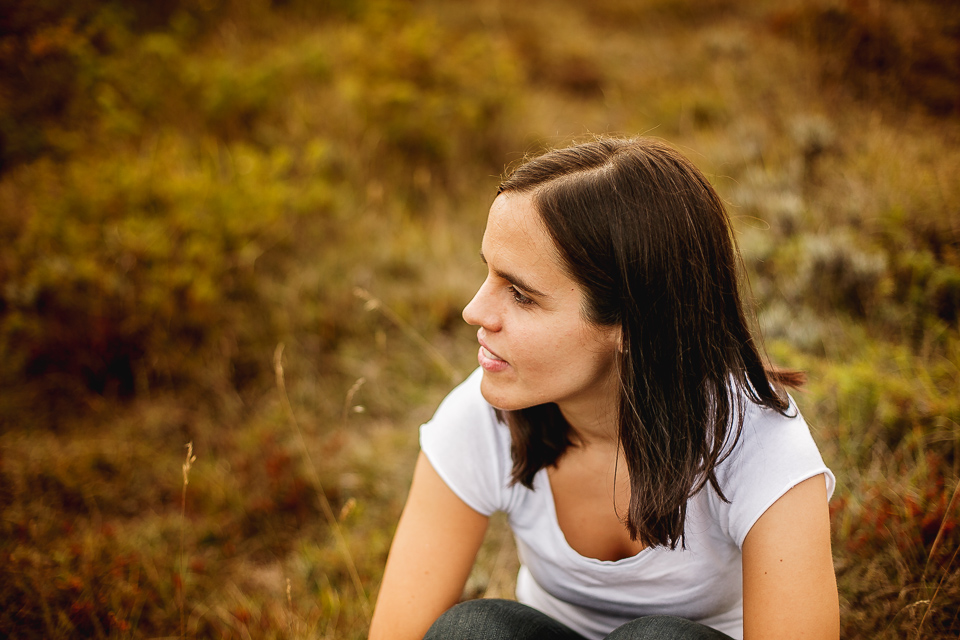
[370,138,839,640]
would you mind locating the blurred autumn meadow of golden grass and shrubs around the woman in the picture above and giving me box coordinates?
[0,0,960,639]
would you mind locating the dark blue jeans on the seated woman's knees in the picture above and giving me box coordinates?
[423,599,731,640]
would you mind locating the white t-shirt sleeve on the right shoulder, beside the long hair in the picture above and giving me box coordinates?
[716,401,836,548]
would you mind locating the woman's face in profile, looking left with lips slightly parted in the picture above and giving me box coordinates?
[463,193,620,419]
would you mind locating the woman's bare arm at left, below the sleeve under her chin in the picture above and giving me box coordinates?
[370,453,488,640]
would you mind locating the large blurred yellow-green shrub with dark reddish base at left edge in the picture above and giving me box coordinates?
[0,135,329,395]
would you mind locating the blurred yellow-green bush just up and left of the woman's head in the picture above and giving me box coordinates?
[336,13,519,171]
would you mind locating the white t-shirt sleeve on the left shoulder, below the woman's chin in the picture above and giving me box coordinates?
[420,369,511,516]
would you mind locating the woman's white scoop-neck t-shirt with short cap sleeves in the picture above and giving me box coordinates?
[420,369,835,639]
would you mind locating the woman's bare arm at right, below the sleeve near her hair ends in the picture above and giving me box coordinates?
[743,475,840,640]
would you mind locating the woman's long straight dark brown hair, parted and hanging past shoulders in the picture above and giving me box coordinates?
[499,138,802,548]
